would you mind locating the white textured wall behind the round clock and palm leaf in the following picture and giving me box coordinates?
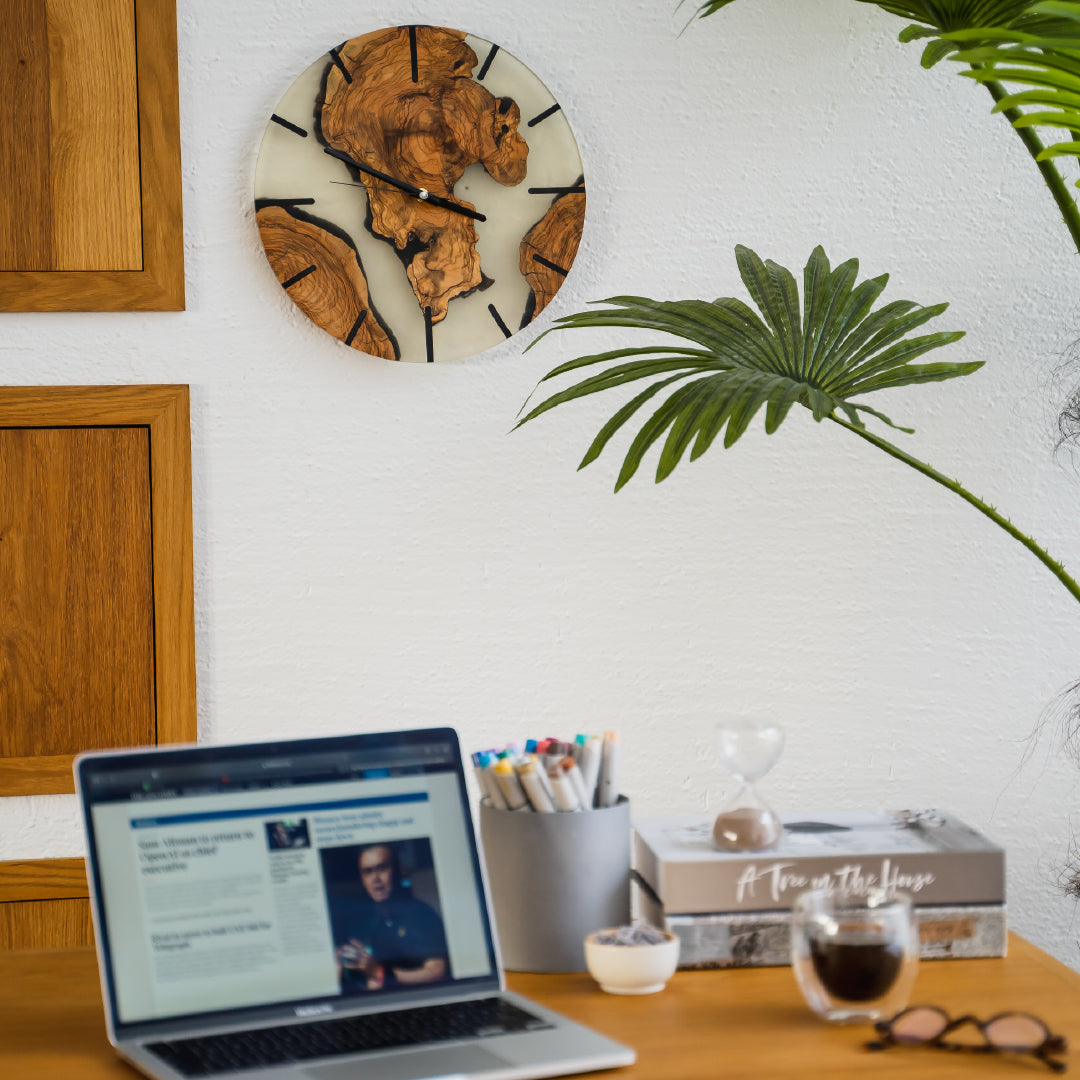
[0,0,1080,968]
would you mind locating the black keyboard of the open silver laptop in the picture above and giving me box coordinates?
[146,998,552,1077]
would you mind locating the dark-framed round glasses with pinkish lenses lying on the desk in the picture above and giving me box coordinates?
[866,1005,1068,1072]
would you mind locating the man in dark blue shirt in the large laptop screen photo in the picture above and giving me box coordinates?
[326,841,448,993]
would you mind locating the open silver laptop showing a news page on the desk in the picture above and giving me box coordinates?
[75,728,635,1080]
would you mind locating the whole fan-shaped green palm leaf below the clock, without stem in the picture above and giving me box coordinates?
[518,246,982,490]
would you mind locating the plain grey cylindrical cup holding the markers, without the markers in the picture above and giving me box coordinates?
[480,795,630,971]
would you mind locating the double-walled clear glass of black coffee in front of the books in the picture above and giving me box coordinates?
[792,889,919,1023]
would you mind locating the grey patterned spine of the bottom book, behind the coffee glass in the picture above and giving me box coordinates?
[632,882,1008,968]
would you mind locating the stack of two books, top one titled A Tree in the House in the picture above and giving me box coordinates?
[632,810,1005,968]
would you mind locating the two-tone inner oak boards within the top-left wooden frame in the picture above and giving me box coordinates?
[0,0,143,270]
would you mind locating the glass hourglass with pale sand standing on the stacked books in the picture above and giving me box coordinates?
[713,720,784,851]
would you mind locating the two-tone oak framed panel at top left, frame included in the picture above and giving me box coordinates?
[0,0,184,311]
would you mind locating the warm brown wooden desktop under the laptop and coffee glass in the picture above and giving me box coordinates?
[0,935,1080,1080]
